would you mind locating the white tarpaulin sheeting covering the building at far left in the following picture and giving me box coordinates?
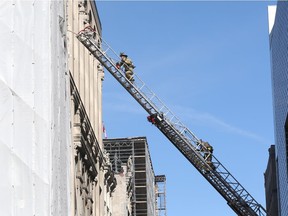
[0,0,71,216]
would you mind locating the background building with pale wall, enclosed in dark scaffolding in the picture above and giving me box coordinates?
[103,137,166,216]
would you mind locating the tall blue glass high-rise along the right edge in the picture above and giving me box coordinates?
[269,1,288,216]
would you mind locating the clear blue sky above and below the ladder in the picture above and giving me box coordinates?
[97,1,274,216]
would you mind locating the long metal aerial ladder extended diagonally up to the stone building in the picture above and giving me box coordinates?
[76,27,268,216]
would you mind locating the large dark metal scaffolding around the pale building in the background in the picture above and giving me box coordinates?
[103,137,156,216]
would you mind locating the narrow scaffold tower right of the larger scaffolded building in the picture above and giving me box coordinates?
[155,175,167,216]
